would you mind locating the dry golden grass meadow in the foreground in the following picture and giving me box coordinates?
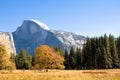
[0,69,120,80]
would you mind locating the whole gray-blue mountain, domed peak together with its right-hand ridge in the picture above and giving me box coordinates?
[13,20,85,54]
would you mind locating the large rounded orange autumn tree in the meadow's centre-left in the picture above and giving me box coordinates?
[34,45,64,69]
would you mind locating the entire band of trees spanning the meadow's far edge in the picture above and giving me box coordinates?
[0,35,120,70]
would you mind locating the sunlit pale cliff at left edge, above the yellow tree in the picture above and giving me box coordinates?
[0,32,16,55]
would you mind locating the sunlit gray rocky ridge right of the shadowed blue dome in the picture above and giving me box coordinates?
[51,30,86,50]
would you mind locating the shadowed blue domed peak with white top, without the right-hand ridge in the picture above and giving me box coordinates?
[13,20,62,54]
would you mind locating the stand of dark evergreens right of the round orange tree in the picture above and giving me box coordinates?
[64,35,120,69]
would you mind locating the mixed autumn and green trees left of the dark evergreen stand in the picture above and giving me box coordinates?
[0,44,64,70]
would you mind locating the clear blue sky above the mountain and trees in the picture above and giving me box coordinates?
[0,0,120,37]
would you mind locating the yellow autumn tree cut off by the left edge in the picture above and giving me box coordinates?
[0,43,15,70]
